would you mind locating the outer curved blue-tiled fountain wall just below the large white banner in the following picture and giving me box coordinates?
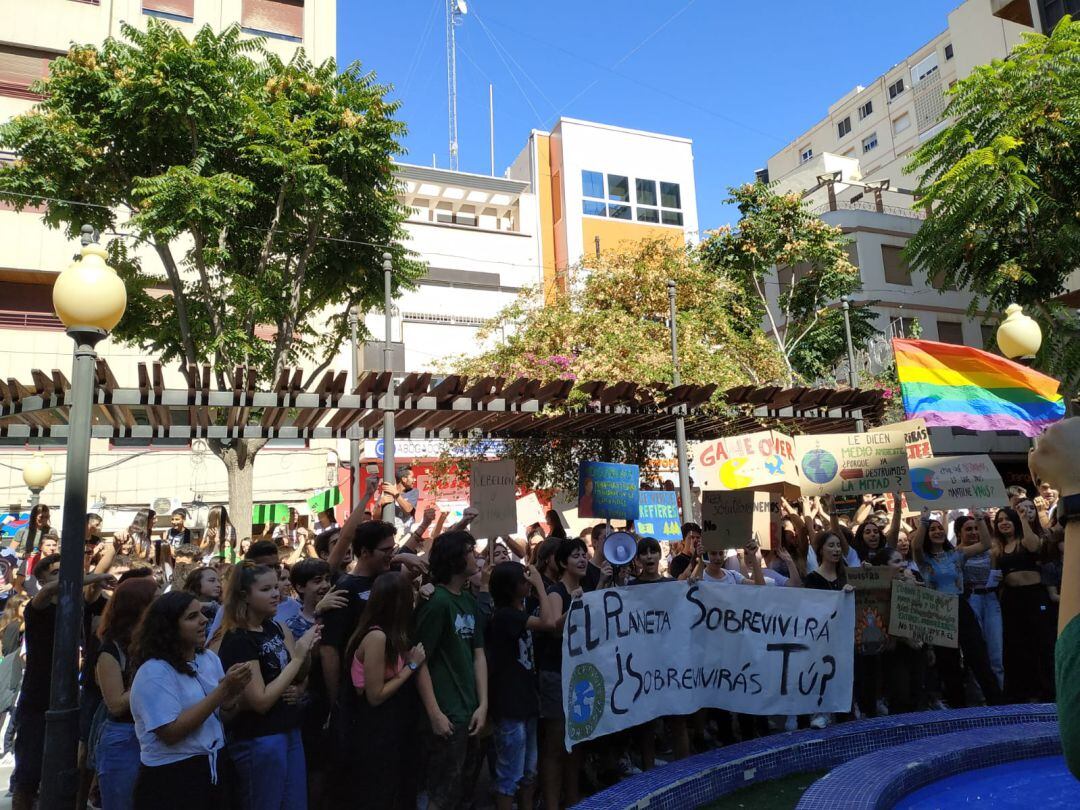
[575,703,1057,810]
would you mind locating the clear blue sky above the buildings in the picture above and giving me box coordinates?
[338,0,961,229]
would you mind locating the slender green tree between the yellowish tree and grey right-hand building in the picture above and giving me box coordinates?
[701,183,876,384]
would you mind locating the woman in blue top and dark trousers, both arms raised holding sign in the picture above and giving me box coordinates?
[912,514,1004,708]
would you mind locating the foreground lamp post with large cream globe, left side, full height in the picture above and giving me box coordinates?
[40,225,127,810]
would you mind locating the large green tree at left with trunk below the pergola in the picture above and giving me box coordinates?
[0,19,421,527]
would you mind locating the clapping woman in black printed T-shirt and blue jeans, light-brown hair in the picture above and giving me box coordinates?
[211,561,322,810]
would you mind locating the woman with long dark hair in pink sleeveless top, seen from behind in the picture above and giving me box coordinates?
[334,572,426,810]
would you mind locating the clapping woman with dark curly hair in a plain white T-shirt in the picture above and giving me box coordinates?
[129,591,252,810]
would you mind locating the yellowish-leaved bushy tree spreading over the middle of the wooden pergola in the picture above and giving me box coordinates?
[453,240,784,489]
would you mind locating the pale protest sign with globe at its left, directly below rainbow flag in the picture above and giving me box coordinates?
[907,456,1009,512]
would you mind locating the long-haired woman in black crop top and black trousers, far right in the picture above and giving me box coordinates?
[993,507,1054,703]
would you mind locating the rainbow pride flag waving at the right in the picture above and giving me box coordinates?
[892,338,1065,436]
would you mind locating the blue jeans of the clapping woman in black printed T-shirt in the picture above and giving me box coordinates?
[227,728,308,810]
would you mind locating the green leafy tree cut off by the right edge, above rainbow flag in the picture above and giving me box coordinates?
[906,17,1080,391]
